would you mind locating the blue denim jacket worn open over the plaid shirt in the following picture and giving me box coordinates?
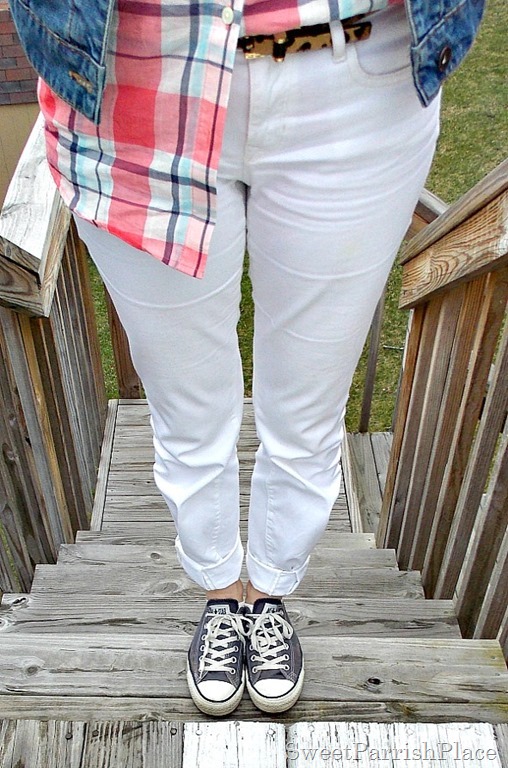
[10,0,485,123]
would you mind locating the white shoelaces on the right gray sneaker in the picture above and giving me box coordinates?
[249,613,293,672]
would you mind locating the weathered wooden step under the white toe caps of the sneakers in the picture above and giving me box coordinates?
[0,633,508,720]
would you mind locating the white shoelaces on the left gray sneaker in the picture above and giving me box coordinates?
[199,613,248,675]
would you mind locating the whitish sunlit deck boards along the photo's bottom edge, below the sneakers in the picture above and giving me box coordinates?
[0,720,506,768]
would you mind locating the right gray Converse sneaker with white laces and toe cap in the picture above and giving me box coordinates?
[245,597,304,712]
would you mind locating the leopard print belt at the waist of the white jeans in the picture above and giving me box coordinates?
[238,14,372,61]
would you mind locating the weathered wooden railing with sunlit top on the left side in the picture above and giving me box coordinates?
[0,117,107,591]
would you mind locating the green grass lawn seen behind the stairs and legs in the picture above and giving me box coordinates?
[89,0,508,431]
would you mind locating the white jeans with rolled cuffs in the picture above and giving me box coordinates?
[78,8,439,595]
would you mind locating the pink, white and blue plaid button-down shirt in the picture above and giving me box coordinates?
[39,0,404,277]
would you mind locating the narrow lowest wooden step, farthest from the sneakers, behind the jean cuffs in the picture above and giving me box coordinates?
[76,524,376,549]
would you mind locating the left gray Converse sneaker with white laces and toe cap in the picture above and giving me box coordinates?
[187,600,248,717]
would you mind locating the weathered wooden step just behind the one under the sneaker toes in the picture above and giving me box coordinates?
[0,592,460,640]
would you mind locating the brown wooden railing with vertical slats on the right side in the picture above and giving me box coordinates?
[378,161,508,655]
